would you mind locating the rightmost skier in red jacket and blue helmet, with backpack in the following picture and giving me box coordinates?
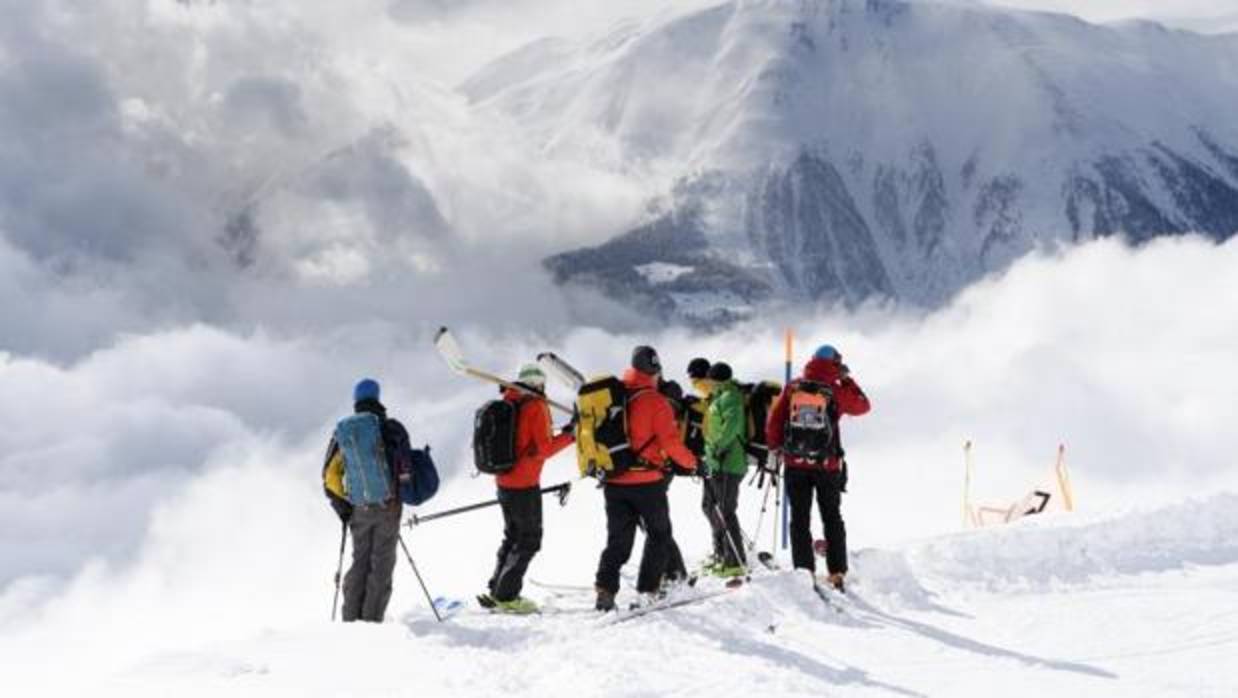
[765,344,870,590]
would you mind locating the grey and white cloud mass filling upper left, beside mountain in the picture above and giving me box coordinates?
[0,0,657,361]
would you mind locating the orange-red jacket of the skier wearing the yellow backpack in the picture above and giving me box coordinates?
[607,369,697,485]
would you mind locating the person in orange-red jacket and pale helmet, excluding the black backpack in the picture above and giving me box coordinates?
[489,364,576,613]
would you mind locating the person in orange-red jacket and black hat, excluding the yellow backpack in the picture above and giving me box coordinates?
[594,347,697,611]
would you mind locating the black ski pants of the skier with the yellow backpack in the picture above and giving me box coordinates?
[594,480,671,594]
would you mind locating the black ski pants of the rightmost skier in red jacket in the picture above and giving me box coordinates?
[785,468,847,574]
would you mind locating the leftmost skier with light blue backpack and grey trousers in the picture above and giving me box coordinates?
[322,379,411,623]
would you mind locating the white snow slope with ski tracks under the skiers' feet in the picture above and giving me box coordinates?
[65,495,1238,696]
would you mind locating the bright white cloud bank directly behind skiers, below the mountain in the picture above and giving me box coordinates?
[0,239,1238,613]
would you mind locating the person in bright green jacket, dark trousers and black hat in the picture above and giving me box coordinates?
[701,361,748,577]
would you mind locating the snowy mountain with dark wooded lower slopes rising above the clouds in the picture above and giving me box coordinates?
[462,0,1238,319]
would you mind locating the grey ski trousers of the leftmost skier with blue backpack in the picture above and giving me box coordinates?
[343,501,400,623]
